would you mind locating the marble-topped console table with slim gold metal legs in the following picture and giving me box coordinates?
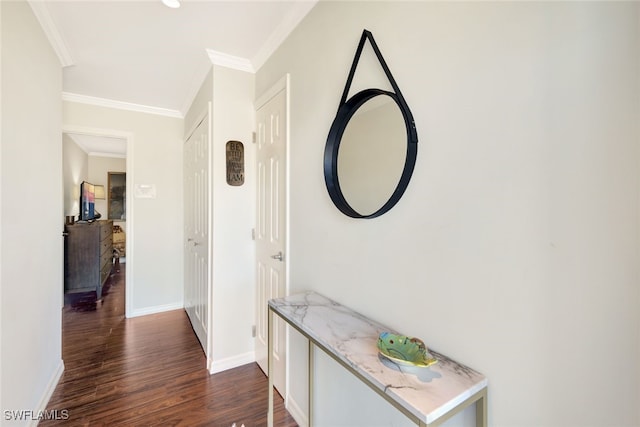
[267,292,487,427]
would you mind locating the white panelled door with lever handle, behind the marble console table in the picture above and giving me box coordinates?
[255,78,288,396]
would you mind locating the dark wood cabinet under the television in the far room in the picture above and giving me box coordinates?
[64,221,113,300]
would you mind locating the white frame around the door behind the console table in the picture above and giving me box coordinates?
[253,73,292,398]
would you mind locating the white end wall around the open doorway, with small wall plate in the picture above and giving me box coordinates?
[62,101,184,316]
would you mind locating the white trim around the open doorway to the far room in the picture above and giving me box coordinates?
[62,125,135,318]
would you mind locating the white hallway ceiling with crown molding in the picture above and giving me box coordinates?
[29,0,317,117]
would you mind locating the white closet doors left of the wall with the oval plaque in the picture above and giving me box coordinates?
[184,115,210,355]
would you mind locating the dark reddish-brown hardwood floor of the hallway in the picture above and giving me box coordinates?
[39,264,297,427]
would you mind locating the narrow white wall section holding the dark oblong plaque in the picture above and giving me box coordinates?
[185,65,256,373]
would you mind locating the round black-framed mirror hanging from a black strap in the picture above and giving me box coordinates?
[324,30,418,218]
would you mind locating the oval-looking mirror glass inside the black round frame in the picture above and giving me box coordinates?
[337,94,407,215]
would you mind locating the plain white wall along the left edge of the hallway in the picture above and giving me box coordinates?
[0,2,63,425]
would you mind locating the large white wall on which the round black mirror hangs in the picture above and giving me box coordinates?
[256,2,640,427]
